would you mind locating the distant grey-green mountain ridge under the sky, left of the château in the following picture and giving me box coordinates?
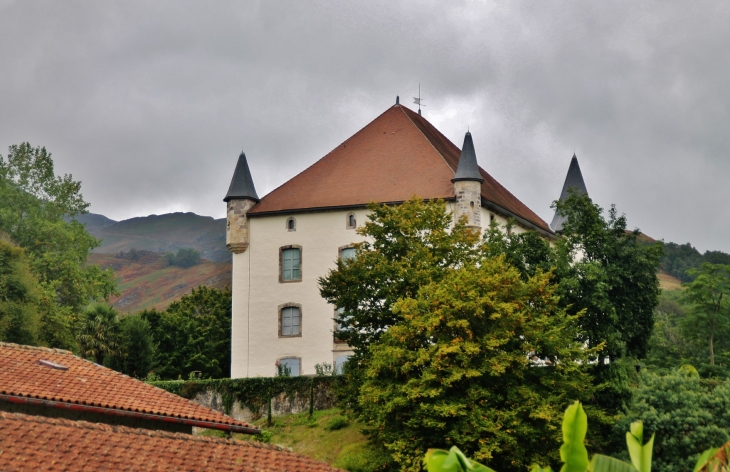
[76,213,231,262]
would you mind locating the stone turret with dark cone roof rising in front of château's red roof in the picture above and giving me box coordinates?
[451,131,484,228]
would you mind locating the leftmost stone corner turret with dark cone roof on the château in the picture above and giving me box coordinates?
[223,153,259,254]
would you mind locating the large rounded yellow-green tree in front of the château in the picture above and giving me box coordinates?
[359,256,596,470]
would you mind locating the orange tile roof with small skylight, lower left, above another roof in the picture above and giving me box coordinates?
[0,343,257,433]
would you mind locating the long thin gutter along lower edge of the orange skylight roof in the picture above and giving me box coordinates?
[0,394,261,434]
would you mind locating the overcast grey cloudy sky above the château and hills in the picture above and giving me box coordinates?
[0,0,730,252]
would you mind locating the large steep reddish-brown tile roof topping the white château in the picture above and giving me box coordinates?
[249,105,552,233]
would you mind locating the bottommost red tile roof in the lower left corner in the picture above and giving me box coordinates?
[0,412,337,472]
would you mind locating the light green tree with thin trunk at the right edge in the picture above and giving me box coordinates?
[684,262,730,365]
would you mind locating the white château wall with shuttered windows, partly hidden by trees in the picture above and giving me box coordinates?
[231,203,525,378]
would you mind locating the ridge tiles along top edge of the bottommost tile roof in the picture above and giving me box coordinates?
[0,411,282,452]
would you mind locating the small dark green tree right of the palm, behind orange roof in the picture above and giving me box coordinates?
[110,315,157,379]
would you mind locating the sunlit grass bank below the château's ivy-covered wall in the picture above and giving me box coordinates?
[202,408,371,472]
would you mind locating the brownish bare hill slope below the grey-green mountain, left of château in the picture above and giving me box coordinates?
[89,252,231,313]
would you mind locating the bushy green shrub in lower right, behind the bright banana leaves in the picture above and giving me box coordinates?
[615,369,730,472]
